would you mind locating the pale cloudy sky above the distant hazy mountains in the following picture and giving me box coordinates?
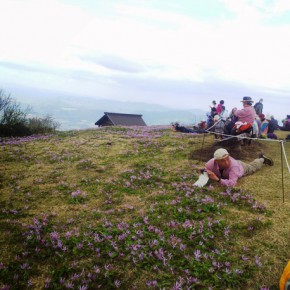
[0,0,290,118]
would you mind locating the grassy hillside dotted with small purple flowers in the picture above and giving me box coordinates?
[0,127,290,290]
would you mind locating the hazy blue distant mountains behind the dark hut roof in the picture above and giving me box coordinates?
[12,94,206,130]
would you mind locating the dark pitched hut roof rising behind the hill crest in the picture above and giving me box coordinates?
[95,112,146,126]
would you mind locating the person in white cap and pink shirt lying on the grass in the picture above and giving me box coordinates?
[205,148,274,187]
